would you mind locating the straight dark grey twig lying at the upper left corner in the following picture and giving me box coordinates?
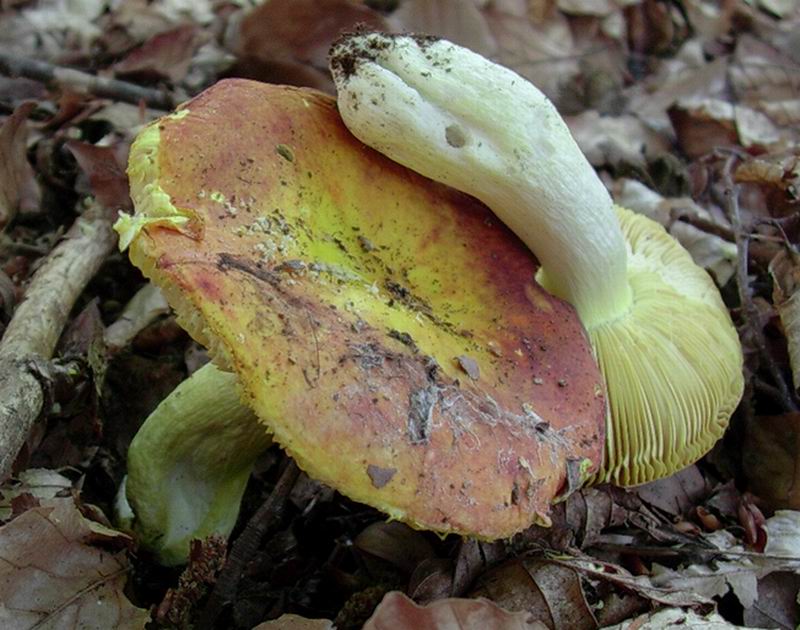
[0,52,178,111]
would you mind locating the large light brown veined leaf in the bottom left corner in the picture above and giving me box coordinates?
[0,498,148,630]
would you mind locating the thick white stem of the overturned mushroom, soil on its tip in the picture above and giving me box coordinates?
[331,33,631,328]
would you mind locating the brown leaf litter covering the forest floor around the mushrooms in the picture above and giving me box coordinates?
[0,0,800,629]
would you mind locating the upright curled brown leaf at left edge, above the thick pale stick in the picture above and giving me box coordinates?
[0,103,40,231]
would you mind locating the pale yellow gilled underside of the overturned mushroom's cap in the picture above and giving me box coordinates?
[589,206,744,486]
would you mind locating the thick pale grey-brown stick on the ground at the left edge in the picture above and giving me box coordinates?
[0,205,117,480]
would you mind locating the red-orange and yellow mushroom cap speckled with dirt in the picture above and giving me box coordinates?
[123,80,605,538]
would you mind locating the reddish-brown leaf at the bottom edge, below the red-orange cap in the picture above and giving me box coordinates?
[364,591,547,630]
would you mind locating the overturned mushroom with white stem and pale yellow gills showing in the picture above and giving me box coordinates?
[331,33,743,485]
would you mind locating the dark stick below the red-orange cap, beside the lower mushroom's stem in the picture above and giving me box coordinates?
[197,459,300,630]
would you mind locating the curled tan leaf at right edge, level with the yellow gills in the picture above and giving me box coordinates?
[769,249,800,389]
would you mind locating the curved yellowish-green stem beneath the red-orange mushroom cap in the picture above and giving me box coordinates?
[125,363,271,564]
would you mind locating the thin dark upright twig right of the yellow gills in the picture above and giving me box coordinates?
[722,156,798,411]
